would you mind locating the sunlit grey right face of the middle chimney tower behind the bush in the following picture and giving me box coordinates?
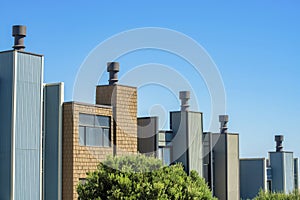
[188,112,203,176]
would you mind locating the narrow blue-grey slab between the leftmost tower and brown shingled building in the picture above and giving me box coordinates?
[43,83,63,200]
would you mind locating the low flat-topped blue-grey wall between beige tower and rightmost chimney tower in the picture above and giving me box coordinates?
[240,158,267,199]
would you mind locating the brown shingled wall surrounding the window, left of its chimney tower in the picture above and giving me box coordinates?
[62,102,114,200]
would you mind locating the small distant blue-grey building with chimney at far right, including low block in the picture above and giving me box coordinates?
[240,135,299,199]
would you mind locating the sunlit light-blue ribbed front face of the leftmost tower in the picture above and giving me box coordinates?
[15,52,43,200]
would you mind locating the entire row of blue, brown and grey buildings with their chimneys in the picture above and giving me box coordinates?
[0,23,299,200]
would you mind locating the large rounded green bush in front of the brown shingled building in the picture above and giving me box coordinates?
[77,155,215,200]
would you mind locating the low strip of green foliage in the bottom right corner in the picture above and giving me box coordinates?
[254,190,300,200]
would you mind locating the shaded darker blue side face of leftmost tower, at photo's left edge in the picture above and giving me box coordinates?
[0,51,14,200]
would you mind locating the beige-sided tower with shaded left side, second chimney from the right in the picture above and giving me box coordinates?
[203,115,240,200]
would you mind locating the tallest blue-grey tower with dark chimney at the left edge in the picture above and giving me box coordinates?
[0,26,44,200]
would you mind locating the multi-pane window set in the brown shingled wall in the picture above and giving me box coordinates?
[79,113,110,147]
